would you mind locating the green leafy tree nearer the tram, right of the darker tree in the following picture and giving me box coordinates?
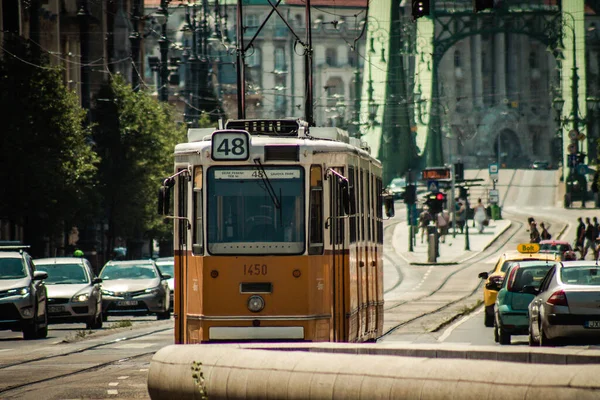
[94,75,185,257]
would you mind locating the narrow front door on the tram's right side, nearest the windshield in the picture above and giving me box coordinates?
[329,168,348,342]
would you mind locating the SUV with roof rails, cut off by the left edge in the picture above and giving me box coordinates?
[0,244,48,339]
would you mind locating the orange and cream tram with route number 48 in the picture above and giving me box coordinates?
[159,119,393,343]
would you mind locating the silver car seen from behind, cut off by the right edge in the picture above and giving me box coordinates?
[523,261,600,346]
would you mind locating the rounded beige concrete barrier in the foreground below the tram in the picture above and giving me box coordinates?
[148,345,600,400]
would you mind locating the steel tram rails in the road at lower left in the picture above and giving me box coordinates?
[0,327,173,398]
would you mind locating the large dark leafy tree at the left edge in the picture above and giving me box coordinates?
[0,33,98,255]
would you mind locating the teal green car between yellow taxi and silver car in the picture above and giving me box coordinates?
[494,260,556,344]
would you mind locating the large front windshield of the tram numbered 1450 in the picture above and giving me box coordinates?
[206,166,305,254]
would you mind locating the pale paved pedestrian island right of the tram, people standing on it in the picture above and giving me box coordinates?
[392,219,511,265]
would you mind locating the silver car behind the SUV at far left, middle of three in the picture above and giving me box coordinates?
[34,257,102,329]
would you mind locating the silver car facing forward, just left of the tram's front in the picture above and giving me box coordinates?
[100,260,171,320]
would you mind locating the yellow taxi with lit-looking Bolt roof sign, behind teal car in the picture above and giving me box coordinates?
[478,243,559,327]
